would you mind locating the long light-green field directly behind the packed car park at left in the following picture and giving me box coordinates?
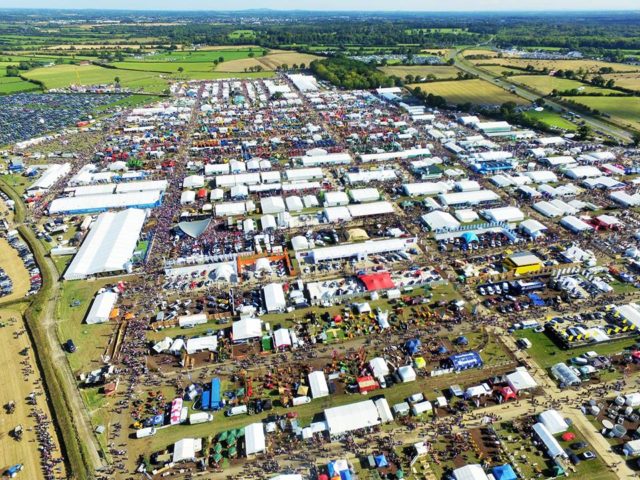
[24,65,169,93]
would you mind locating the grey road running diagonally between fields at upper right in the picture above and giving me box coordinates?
[452,49,632,143]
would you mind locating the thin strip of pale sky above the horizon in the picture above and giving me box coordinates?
[8,0,640,11]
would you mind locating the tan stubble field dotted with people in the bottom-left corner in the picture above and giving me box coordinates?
[0,309,67,480]
